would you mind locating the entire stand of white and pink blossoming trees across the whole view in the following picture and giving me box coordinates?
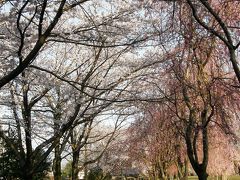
[0,0,240,180]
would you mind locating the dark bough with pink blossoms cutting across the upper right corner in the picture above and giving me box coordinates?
[186,0,240,82]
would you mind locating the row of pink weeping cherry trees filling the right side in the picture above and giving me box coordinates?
[114,0,239,179]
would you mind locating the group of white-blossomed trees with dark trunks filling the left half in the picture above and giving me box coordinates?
[0,0,148,179]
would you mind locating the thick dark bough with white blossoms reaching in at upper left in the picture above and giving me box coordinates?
[0,0,149,87]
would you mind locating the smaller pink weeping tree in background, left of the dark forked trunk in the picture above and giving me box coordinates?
[127,104,187,179]
